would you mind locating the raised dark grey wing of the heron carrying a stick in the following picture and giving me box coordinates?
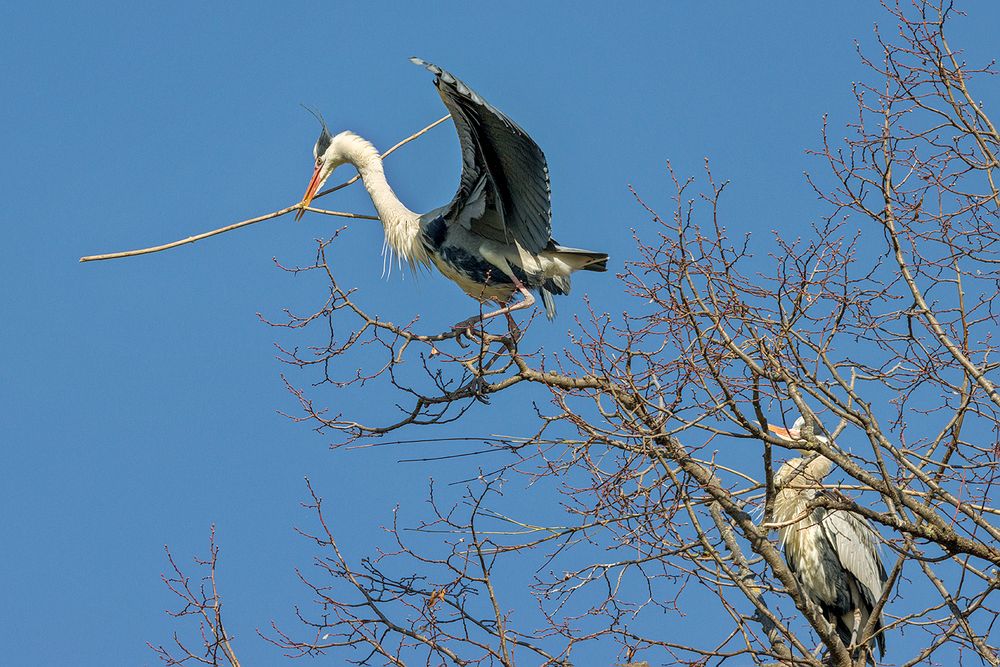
[411,58,552,253]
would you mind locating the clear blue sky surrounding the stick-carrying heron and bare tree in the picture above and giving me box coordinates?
[0,2,1000,666]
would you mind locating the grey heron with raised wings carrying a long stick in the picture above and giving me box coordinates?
[296,58,608,330]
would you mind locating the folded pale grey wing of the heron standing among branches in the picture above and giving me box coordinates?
[820,510,888,606]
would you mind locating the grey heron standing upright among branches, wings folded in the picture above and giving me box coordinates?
[768,417,887,657]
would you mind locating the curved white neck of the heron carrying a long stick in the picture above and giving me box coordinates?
[343,132,429,265]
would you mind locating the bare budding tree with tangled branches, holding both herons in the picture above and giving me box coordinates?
[152,0,1000,667]
